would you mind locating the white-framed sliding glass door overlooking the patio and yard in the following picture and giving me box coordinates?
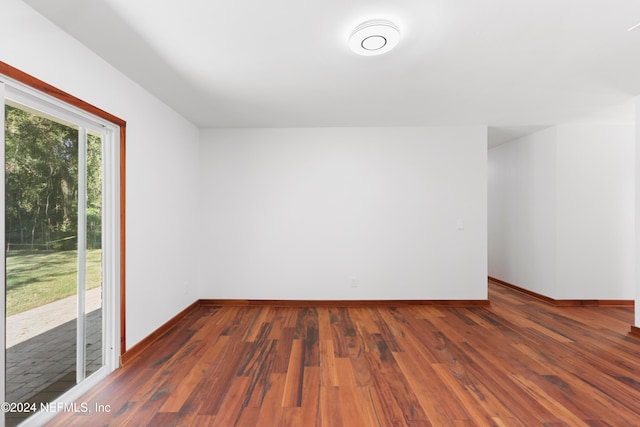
[2,77,116,425]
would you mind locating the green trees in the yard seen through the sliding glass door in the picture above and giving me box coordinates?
[5,105,102,249]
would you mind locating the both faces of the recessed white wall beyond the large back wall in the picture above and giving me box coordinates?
[488,118,635,299]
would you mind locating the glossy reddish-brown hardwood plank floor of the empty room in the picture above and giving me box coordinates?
[50,283,640,427]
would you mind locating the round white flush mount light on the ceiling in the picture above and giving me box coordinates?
[349,19,400,56]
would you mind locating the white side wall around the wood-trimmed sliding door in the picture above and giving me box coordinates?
[0,0,198,347]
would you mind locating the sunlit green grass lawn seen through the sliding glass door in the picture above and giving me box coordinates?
[6,249,102,316]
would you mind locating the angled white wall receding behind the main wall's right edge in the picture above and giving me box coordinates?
[488,128,556,296]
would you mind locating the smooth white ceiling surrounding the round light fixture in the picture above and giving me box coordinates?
[24,0,640,142]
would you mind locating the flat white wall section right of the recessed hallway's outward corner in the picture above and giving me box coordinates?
[554,124,635,300]
